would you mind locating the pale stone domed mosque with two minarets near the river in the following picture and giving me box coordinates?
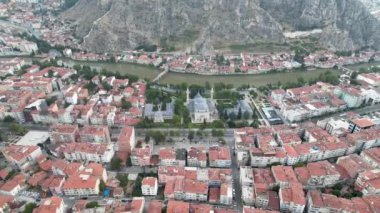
[186,88,218,124]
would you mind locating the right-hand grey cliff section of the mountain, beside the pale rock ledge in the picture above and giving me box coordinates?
[260,0,380,50]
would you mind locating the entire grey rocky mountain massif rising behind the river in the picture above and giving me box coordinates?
[61,0,380,52]
